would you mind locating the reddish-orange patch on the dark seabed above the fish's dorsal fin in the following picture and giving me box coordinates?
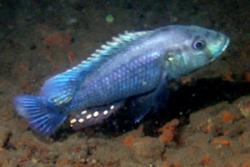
[43,32,72,47]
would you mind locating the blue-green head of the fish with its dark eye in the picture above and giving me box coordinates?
[166,26,230,78]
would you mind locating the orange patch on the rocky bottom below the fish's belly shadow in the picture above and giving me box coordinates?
[158,119,180,145]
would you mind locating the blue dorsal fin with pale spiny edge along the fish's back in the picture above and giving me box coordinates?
[41,31,152,106]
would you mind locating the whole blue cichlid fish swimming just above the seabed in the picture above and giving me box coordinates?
[14,25,230,136]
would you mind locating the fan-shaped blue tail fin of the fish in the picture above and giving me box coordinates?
[14,95,67,136]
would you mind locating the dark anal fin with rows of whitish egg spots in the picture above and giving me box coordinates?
[69,102,124,130]
